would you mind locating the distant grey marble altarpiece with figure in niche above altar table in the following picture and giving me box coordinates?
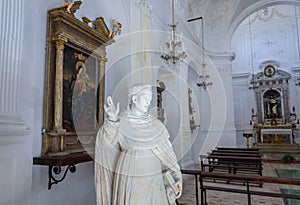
[251,65,295,145]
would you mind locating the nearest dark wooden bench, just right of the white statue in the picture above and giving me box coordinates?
[200,172,300,205]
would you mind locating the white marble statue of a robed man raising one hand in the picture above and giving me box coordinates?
[95,84,182,205]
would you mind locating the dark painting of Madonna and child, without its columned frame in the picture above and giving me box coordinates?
[63,46,98,132]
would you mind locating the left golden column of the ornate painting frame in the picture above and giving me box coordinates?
[53,36,67,132]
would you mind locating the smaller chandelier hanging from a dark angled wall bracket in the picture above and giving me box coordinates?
[187,16,213,89]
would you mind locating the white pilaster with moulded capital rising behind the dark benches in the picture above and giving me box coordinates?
[199,52,236,154]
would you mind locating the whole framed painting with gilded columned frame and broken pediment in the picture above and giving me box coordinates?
[42,1,114,156]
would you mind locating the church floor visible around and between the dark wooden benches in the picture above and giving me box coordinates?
[178,163,300,205]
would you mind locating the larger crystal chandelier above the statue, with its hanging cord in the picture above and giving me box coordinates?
[160,0,186,64]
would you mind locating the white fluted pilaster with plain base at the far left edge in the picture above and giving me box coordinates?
[0,0,32,205]
